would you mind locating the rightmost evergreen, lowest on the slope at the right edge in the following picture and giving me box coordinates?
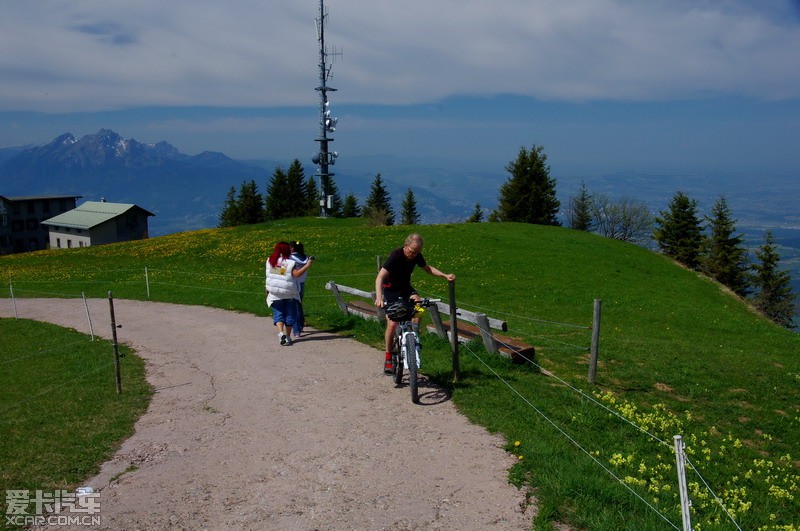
[752,231,797,328]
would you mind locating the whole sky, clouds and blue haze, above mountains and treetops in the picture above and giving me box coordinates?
[0,0,800,179]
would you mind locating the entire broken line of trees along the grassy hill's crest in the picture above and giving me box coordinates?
[219,144,796,327]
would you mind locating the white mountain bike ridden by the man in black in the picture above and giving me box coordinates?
[386,299,441,404]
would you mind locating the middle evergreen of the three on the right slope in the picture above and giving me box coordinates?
[702,196,750,296]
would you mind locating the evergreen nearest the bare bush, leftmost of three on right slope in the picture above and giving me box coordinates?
[653,192,703,269]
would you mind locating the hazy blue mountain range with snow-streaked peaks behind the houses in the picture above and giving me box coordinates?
[0,129,474,236]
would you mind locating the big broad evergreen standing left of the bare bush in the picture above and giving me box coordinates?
[498,145,561,225]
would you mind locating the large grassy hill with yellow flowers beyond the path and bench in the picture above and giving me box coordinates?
[0,219,800,529]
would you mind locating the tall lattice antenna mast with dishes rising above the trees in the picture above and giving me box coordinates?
[311,0,341,218]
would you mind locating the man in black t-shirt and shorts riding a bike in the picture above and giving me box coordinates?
[375,233,456,374]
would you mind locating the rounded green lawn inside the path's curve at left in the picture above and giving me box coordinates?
[0,319,151,528]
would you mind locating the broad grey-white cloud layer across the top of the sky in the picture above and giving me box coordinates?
[0,0,800,112]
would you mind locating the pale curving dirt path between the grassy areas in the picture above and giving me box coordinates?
[0,299,533,530]
